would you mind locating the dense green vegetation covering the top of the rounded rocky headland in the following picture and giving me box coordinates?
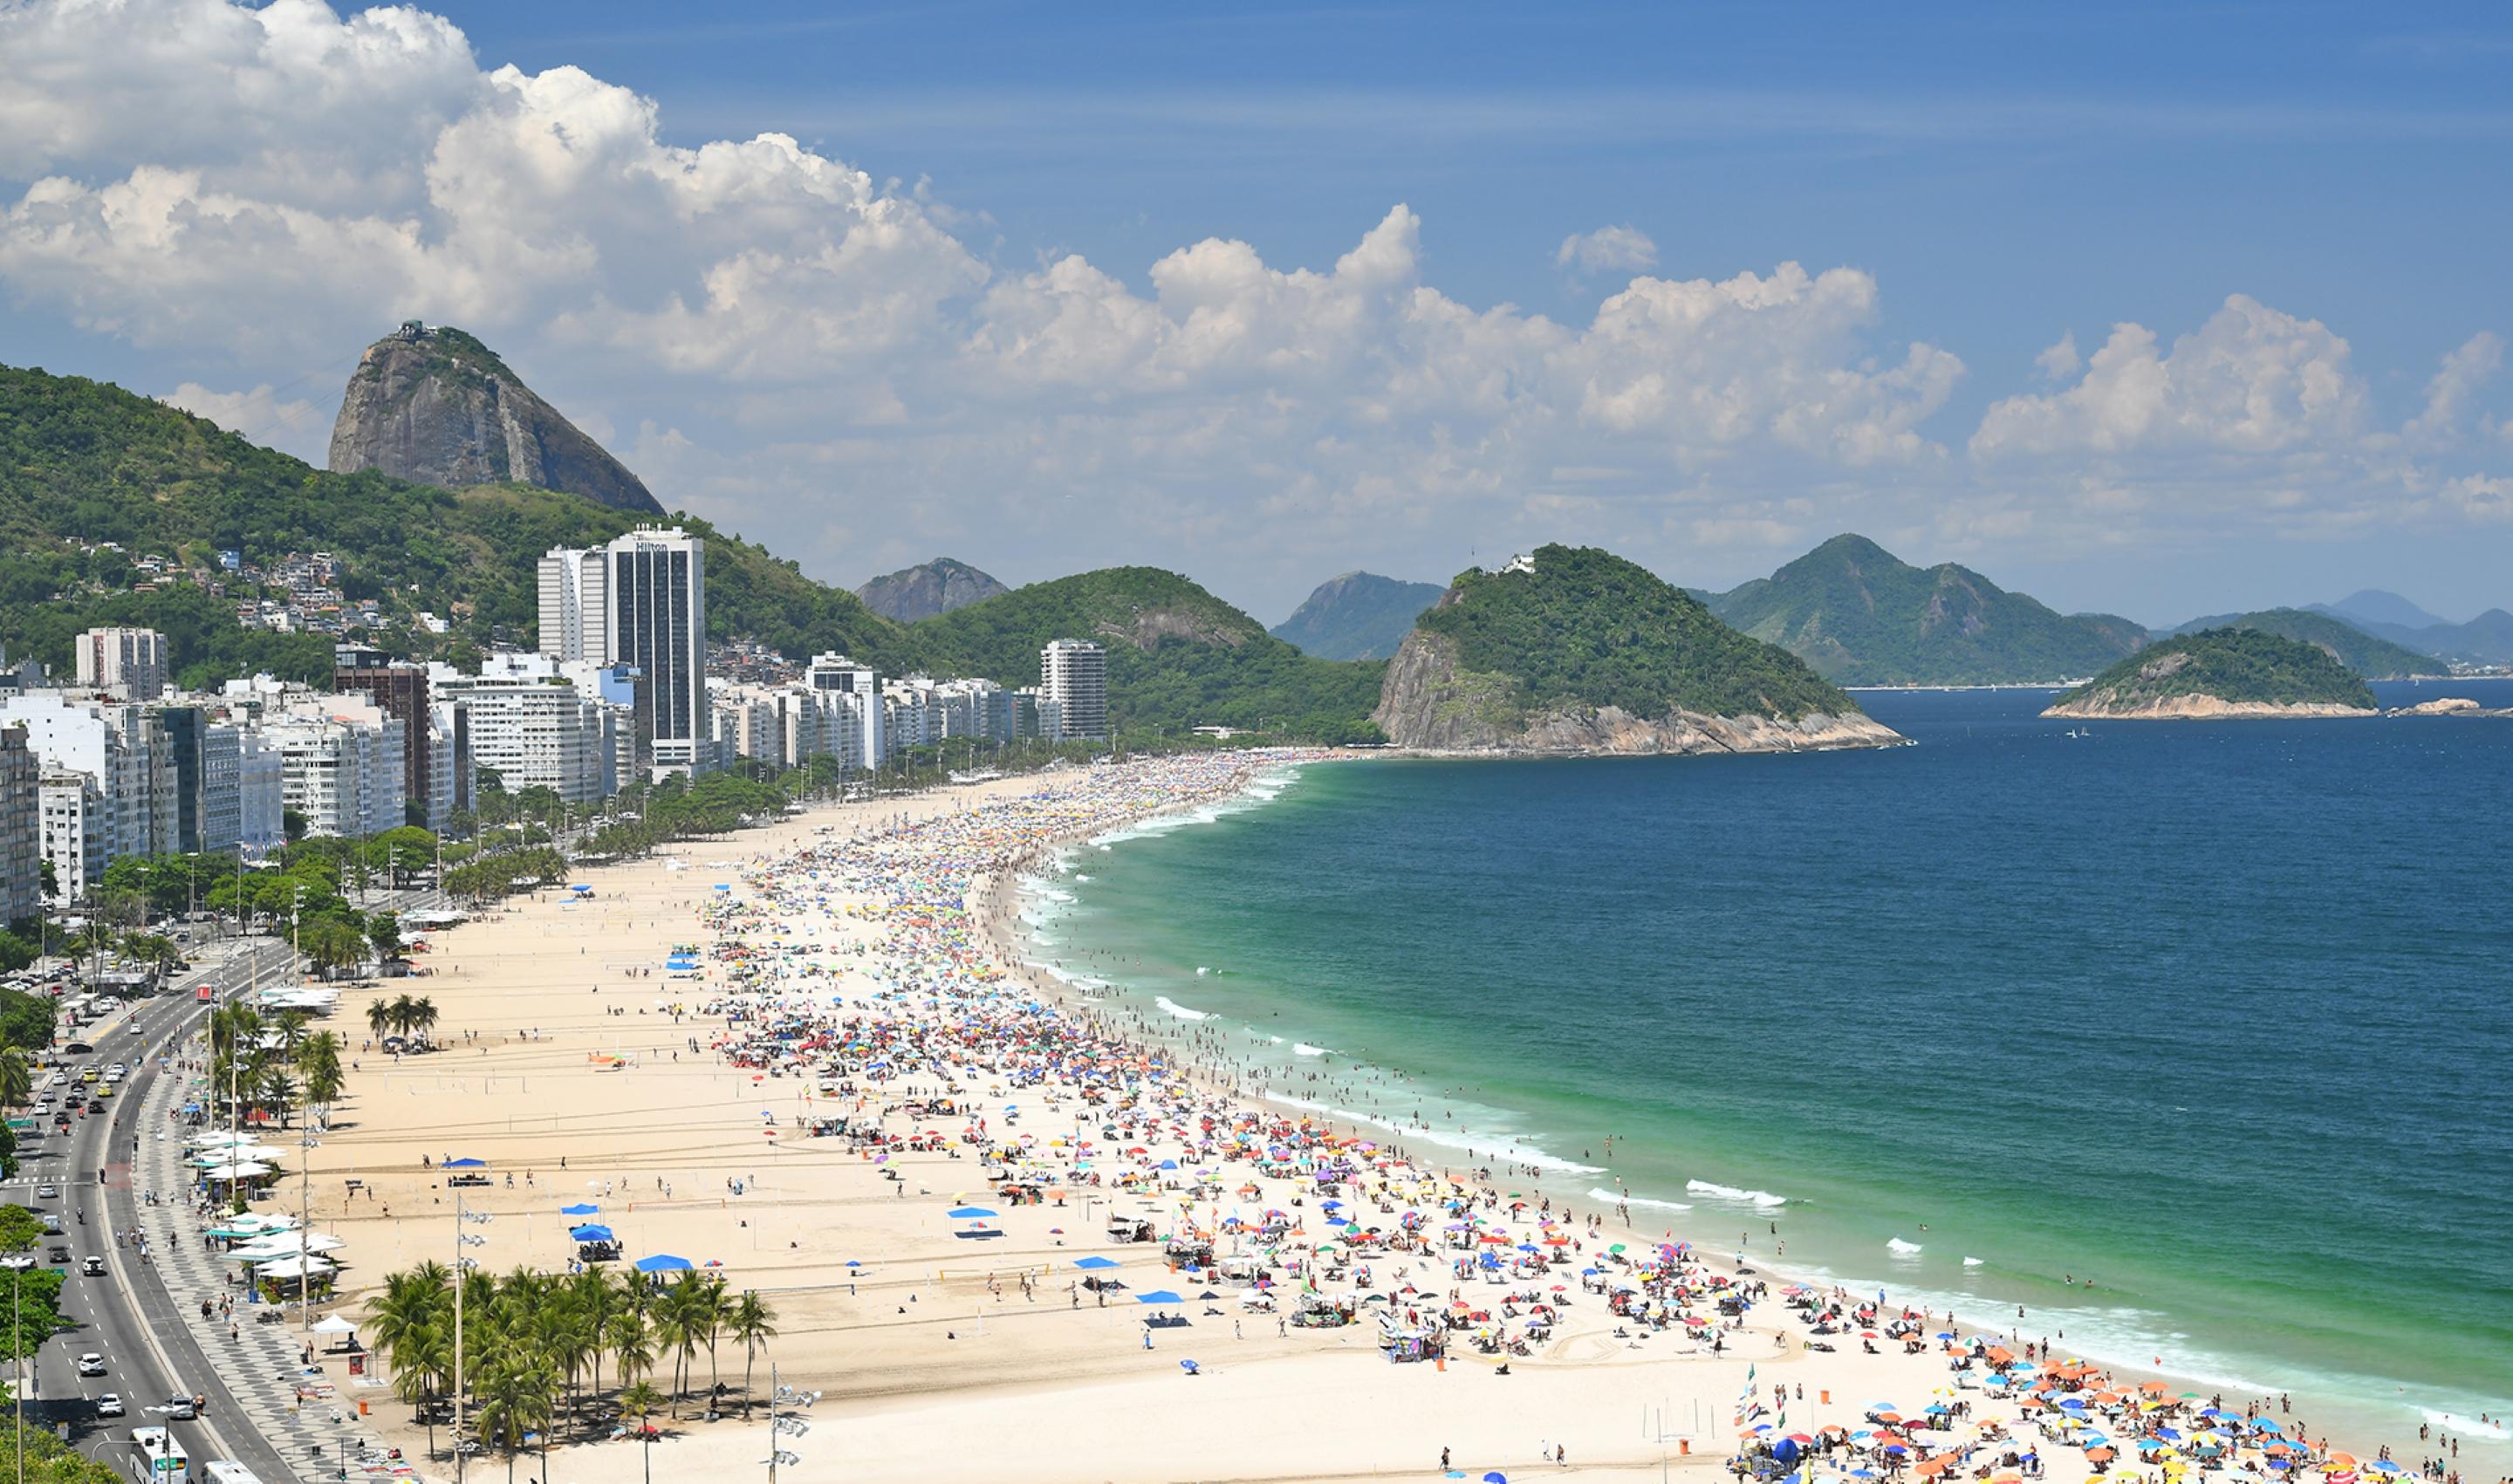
[1420,545,1857,721]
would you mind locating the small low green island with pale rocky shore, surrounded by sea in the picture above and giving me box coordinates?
[2043,628,2377,721]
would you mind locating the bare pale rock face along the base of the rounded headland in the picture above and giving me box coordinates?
[1372,628,1902,756]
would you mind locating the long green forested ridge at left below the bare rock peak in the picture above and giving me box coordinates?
[0,366,900,683]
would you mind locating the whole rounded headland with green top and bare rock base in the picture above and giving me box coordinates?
[1372,545,1905,756]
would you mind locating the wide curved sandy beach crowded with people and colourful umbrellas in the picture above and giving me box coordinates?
[250,756,2412,1484]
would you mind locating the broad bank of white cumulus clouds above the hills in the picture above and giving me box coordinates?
[0,0,2503,610]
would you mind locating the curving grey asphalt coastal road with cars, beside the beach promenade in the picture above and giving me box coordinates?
[10,939,302,1484]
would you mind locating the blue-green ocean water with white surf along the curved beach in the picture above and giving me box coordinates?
[1031,680,2513,1476]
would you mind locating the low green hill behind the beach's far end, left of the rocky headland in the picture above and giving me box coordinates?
[907,567,1385,741]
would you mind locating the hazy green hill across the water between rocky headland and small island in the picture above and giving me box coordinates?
[1707,535,2147,686]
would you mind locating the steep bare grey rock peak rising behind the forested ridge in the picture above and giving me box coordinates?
[329,326,663,515]
